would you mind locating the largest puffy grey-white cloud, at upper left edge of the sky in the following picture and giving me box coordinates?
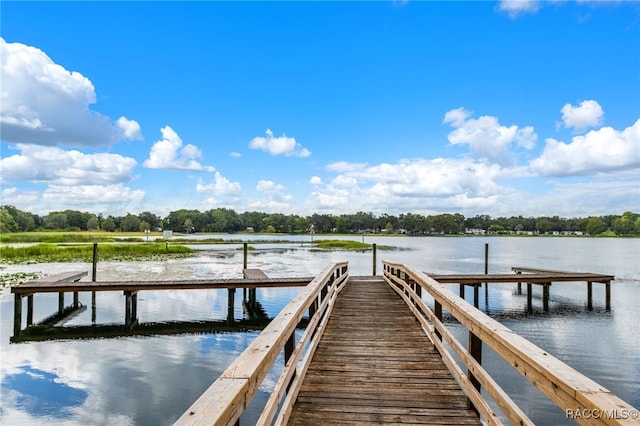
[0,38,142,147]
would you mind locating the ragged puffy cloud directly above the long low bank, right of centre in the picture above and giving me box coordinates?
[443,108,538,165]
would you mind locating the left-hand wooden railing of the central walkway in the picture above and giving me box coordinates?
[176,262,348,425]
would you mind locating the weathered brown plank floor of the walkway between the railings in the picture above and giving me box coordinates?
[289,277,480,425]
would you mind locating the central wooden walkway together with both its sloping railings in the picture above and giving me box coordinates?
[171,262,640,425]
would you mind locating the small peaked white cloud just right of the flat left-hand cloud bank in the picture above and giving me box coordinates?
[143,126,214,171]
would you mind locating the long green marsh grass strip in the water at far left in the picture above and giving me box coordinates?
[0,244,193,264]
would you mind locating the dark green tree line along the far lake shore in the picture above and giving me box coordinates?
[0,206,640,235]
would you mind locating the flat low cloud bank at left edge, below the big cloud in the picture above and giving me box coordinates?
[0,144,137,186]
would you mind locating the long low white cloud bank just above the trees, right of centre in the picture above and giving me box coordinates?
[312,158,528,213]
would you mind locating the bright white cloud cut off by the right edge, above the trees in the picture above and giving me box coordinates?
[531,120,640,176]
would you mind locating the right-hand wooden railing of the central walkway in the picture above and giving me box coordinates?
[383,261,638,425]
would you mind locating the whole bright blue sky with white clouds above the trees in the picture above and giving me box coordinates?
[0,1,640,217]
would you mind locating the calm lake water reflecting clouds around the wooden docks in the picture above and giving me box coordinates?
[0,236,640,425]
